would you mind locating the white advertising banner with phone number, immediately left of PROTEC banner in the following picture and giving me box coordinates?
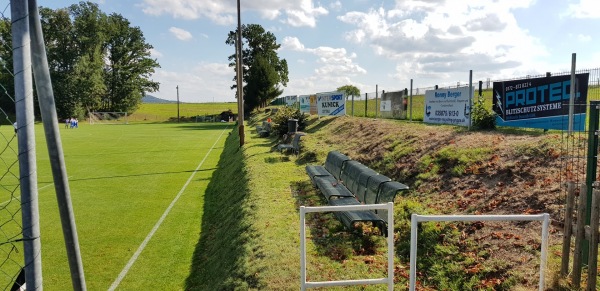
[423,87,475,126]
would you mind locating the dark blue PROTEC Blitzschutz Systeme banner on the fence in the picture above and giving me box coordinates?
[493,73,589,131]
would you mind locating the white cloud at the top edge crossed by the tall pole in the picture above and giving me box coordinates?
[138,0,328,27]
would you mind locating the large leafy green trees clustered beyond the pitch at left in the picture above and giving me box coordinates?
[0,2,160,118]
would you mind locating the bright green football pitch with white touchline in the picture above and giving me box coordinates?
[0,123,234,290]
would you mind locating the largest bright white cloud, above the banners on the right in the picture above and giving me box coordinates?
[338,0,544,83]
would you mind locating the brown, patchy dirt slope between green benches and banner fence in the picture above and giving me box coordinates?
[309,117,585,289]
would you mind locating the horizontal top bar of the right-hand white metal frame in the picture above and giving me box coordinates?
[412,213,550,222]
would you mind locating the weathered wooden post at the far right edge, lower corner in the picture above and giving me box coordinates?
[586,186,600,291]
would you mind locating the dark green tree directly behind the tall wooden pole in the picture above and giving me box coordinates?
[225,24,289,111]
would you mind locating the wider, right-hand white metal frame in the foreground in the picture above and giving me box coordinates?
[409,213,550,291]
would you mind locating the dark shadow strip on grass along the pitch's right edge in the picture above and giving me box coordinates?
[185,130,261,290]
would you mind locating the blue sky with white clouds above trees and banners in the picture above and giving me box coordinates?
[21,0,600,103]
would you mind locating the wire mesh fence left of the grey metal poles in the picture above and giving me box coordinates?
[0,0,24,290]
